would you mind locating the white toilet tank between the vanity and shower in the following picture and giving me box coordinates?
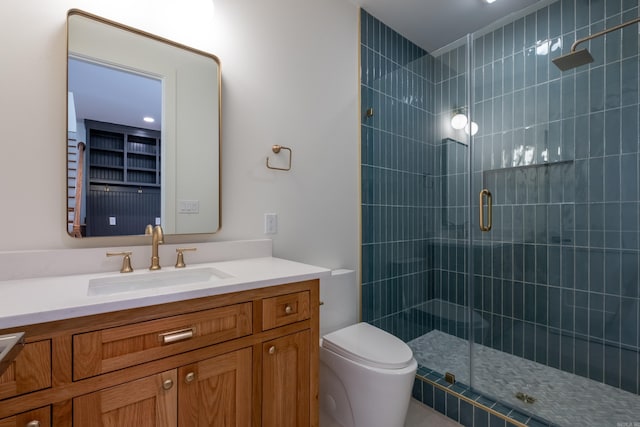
[320,269,359,337]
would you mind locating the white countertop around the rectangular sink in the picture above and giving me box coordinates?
[0,257,331,329]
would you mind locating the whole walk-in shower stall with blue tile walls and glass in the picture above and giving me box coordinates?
[360,0,640,427]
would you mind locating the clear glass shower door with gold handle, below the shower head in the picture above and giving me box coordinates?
[468,1,640,426]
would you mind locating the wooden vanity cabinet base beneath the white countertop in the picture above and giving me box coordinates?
[0,280,319,427]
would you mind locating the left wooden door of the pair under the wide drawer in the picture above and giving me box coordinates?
[73,370,178,427]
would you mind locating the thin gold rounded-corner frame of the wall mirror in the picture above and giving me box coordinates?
[65,9,222,239]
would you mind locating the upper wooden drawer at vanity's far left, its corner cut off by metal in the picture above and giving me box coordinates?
[0,340,51,399]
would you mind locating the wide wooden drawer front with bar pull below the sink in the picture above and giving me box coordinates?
[73,302,252,380]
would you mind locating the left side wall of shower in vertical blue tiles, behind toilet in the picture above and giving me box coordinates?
[360,10,435,340]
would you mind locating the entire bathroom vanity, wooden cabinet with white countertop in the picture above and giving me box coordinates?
[0,258,328,427]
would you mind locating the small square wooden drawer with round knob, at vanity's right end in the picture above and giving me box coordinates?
[262,291,310,330]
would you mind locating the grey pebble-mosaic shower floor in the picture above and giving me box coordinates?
[408,330,640,427]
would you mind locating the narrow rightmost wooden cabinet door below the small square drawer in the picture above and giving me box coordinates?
[262,330,311,427]
